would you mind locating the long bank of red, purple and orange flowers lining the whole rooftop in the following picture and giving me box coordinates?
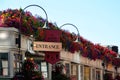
[0,9,120,66]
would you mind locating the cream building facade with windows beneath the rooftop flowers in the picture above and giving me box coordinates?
[0,27,120,80]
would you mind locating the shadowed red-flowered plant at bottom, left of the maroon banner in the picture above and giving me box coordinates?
[12,59,44,80]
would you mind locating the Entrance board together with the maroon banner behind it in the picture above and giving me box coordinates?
[33,29,62,64]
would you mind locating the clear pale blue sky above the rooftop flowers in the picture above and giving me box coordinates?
[0,0,120,51]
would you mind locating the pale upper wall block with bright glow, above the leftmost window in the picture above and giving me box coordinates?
[0,28,18,48]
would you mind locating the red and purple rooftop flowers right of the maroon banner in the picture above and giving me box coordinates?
[61,32,117,63]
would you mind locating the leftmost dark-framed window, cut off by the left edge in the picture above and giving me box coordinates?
[0,53,8,76]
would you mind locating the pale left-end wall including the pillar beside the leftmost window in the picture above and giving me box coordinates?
[0,27,18,77]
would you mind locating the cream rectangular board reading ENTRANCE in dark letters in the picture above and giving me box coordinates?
[33,42,62,52]
